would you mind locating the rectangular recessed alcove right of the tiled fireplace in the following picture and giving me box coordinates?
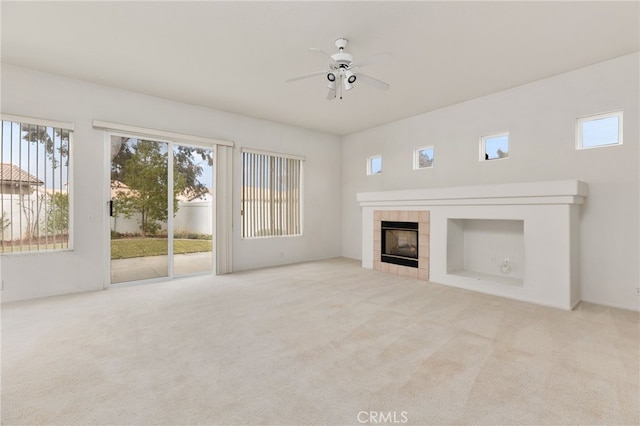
[447,219,525,286]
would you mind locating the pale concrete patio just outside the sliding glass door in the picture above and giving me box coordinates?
[111,251,213,284]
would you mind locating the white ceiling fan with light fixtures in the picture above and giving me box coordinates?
[287,38,391,100]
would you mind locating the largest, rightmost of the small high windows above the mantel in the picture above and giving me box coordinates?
[576,111,622,149]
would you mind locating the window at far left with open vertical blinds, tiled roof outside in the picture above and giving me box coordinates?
[0,115,73,253]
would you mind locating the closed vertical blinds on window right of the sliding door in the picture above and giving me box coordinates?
[242,151,302,238]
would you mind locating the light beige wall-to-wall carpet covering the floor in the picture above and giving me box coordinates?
[2,259,640,425]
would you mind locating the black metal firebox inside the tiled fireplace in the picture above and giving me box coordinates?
[380,221,418,268]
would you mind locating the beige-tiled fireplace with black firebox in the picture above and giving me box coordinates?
[373,210,429,280]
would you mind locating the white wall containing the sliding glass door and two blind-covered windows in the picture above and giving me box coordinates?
[1,65,341,301]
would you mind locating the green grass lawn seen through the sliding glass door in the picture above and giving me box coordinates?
[111,238,211,259]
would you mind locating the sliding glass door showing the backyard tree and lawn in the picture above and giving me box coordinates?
[110,134,214,284]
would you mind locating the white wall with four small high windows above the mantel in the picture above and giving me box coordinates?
[342,54,640,309]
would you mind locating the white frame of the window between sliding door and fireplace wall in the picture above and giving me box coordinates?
[240,148,306,240]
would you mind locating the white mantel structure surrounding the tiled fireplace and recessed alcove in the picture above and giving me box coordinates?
[357,180,588,310]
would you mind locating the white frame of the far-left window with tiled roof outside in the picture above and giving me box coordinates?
[0,113,75,256]
